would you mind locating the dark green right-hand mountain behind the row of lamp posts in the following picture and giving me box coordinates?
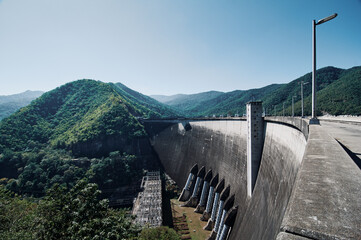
[270,67,361,116]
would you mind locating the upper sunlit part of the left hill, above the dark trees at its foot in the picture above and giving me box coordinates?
[0,80,175,158]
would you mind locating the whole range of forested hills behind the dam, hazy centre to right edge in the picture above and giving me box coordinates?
[154,67,361,117]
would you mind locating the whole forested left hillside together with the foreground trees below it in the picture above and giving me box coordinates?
[0,80,178,239]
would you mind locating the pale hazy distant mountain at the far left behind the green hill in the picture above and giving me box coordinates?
[0,91,44,120]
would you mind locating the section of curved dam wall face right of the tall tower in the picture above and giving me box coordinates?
[231,122,306,240]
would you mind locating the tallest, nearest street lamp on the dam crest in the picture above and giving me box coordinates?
[310,13,337,124]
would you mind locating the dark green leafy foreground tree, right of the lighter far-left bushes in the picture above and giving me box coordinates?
[36,180,139,240]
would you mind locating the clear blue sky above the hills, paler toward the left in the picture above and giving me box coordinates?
[0,0,361,95]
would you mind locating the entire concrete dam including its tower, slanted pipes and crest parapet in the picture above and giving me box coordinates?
[143,102,361,240]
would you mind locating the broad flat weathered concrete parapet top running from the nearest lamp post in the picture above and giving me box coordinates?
[277,125,361,239]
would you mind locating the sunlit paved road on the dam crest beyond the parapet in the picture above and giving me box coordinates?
[320,120,361,168]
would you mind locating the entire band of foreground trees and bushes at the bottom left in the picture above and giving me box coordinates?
[0,180,140,239]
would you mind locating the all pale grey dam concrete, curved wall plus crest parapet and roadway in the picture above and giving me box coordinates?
[142,117,361,240]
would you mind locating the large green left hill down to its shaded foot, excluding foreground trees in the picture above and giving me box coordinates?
[0,80,176,196]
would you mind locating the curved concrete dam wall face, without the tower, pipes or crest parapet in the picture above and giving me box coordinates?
[145,119,306,240]
